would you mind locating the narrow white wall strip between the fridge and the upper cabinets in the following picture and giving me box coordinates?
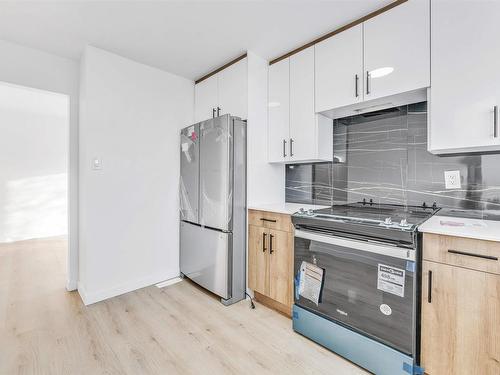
[247,52,285,206]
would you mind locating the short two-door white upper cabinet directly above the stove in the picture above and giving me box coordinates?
[315,0,430,118]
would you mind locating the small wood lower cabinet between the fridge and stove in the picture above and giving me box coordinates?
[248,210,293,316]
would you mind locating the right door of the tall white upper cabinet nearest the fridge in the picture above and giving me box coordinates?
[288,47,318,161]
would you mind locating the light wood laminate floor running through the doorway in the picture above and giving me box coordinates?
[0,238,366,375]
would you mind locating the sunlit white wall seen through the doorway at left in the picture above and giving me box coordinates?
[0,83,69,242]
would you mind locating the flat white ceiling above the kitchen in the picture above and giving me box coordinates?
[0,0,391,79]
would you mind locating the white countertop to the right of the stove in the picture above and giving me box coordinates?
[418,216,500,241]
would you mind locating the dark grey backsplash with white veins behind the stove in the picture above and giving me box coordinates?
[286,102,500,211]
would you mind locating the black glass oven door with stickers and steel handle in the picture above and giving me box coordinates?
[294,230,416,355]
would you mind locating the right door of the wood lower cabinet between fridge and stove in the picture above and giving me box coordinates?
[269,230,293,306]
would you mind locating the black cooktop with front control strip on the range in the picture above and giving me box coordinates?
[292,200,439,244]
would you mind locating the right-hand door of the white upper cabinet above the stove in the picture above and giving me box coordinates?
[364,0,430,100]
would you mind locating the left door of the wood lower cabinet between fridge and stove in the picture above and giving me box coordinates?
[248,225,269,295]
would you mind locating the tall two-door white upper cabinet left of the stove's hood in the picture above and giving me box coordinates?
[268,47,333,163]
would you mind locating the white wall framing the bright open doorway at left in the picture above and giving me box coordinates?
[0,40,79,290]
